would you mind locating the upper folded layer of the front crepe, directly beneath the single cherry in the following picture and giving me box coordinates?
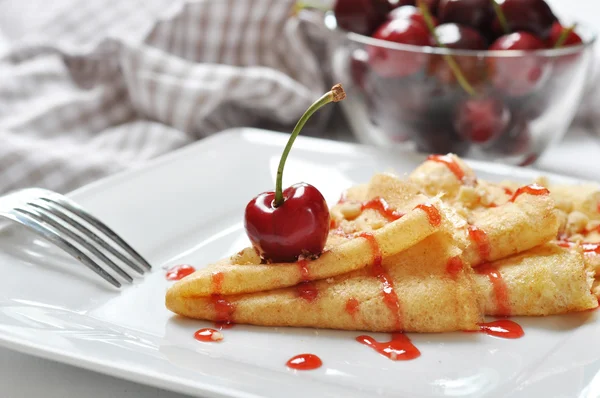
[171,202,439,297]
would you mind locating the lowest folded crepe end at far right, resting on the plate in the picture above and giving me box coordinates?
[474,243,598,316]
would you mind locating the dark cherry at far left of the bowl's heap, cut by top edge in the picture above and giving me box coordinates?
[333,0,392,35]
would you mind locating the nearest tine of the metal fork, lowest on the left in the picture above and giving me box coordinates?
[10,209,121,288]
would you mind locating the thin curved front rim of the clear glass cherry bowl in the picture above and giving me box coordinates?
[324,11,598,58]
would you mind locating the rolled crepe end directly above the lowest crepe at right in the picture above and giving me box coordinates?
[455,190,560,267]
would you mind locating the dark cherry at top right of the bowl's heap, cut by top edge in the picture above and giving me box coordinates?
[495,0,556,39]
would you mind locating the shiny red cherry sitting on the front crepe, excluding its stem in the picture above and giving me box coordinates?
[245,183,329,262]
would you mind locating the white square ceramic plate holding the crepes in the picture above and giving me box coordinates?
[0,129,600,398]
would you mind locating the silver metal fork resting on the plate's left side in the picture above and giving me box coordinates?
[0,188,152,288]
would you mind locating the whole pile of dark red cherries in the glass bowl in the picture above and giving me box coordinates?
[334,0,582,162]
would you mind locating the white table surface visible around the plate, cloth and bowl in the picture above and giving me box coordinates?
[0,0,600,398]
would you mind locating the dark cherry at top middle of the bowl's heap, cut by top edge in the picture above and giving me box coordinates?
[437,0,494,30]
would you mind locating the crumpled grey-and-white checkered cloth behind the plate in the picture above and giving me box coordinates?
[0,0,331,194]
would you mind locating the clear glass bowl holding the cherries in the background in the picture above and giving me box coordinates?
[325,12,596,165]
